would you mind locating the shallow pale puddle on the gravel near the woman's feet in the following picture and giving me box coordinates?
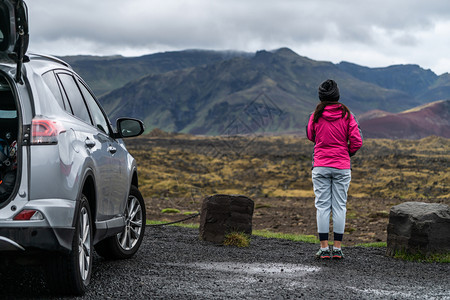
[179,262,320,277]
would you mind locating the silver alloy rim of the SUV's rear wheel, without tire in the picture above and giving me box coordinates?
[78,207,91,281]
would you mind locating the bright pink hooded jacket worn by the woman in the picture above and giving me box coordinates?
[306,104,363,169]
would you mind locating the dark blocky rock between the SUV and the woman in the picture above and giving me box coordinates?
[200,195,254,243]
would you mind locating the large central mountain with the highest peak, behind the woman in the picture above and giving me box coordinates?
[100,48,428,135]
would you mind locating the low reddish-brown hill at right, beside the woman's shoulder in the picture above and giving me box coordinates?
[360,100,450,139]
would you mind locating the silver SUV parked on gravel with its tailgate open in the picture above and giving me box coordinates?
[0,0,145,294]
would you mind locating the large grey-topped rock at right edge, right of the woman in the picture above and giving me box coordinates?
[386,202,450,256]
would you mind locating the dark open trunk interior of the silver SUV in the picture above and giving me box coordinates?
[0,73,19,207]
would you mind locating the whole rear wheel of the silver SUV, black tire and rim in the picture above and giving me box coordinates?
[47,195,93,295]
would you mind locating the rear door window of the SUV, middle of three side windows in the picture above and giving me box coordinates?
[58,73,92,124]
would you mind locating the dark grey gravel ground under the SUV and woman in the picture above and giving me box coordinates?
[0,226,450,299]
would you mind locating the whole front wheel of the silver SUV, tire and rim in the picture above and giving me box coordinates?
[95,186,146,259]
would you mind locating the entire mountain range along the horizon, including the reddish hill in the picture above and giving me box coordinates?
[63,48,450,138]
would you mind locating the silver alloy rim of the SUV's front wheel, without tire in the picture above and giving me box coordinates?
[117,196,142,251]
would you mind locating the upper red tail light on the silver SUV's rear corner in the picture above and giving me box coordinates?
[31,119,65,145]
